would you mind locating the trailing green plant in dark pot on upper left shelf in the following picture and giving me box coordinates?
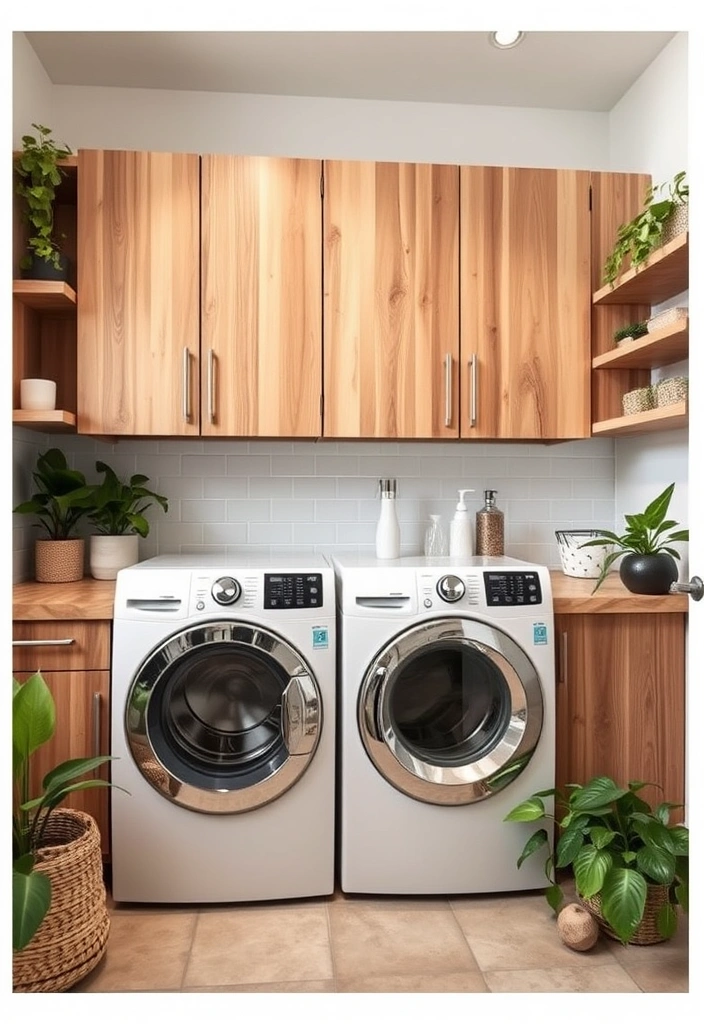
[14,124,72,281]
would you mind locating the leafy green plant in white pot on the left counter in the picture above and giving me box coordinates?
[88,462,169,580]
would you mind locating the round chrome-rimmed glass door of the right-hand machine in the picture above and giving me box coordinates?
[358,618,543,805]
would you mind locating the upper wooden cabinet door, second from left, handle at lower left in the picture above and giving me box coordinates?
[201,156,322,437]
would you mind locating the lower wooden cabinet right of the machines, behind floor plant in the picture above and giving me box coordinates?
[555,612,687,820]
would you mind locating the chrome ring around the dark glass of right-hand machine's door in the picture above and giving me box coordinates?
[357,618,543,805]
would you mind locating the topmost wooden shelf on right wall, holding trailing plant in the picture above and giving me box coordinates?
[591,231,690,306]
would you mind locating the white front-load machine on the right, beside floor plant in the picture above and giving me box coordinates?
[333,555,555,895]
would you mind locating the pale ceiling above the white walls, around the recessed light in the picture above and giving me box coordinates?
[27,32,675,111]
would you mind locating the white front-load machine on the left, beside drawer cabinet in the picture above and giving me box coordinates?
[111,555,336,903]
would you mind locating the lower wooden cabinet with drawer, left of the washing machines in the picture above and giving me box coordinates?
[12,620,111,857]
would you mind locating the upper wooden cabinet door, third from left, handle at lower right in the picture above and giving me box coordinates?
[323,161,459,437]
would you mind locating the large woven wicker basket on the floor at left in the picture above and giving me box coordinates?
[12,809,109,992]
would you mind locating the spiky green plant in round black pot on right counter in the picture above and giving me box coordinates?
[580,483,690,594]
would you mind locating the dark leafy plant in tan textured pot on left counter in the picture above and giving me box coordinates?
[12,447,93,583]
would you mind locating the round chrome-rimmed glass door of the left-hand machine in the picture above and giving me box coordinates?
[125,622,322,814]
